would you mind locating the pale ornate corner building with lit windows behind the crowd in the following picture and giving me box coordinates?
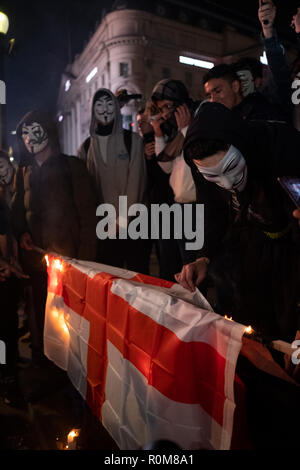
[57,2,272,155]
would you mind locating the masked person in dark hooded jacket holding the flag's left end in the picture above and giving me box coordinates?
[12,110,97,364]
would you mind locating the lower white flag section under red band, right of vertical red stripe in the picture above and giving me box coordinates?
[102,342,226,450]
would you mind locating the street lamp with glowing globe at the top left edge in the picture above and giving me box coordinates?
[0,11,9,148]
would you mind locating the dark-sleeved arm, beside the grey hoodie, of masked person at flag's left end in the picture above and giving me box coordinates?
[69,157,97,261]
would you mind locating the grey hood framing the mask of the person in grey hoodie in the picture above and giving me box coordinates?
[90,88,123,136]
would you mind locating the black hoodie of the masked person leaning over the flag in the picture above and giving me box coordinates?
[185,104,300,341]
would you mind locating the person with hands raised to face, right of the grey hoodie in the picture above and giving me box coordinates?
[151,79,198,274]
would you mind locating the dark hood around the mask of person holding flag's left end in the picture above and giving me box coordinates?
[17,110,60,164]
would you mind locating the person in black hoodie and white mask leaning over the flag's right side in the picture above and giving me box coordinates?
[177,103,300,449]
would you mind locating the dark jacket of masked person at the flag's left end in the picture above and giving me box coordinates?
[12,155,97,261]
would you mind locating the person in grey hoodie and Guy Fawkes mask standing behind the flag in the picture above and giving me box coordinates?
[78,88,149,274]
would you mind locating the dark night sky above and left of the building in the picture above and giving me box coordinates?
[0,0,300,147]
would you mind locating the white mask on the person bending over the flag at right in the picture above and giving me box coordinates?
[194,145,248,192]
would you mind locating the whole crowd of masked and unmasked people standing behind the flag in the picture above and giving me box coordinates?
[0,1,300,448]
